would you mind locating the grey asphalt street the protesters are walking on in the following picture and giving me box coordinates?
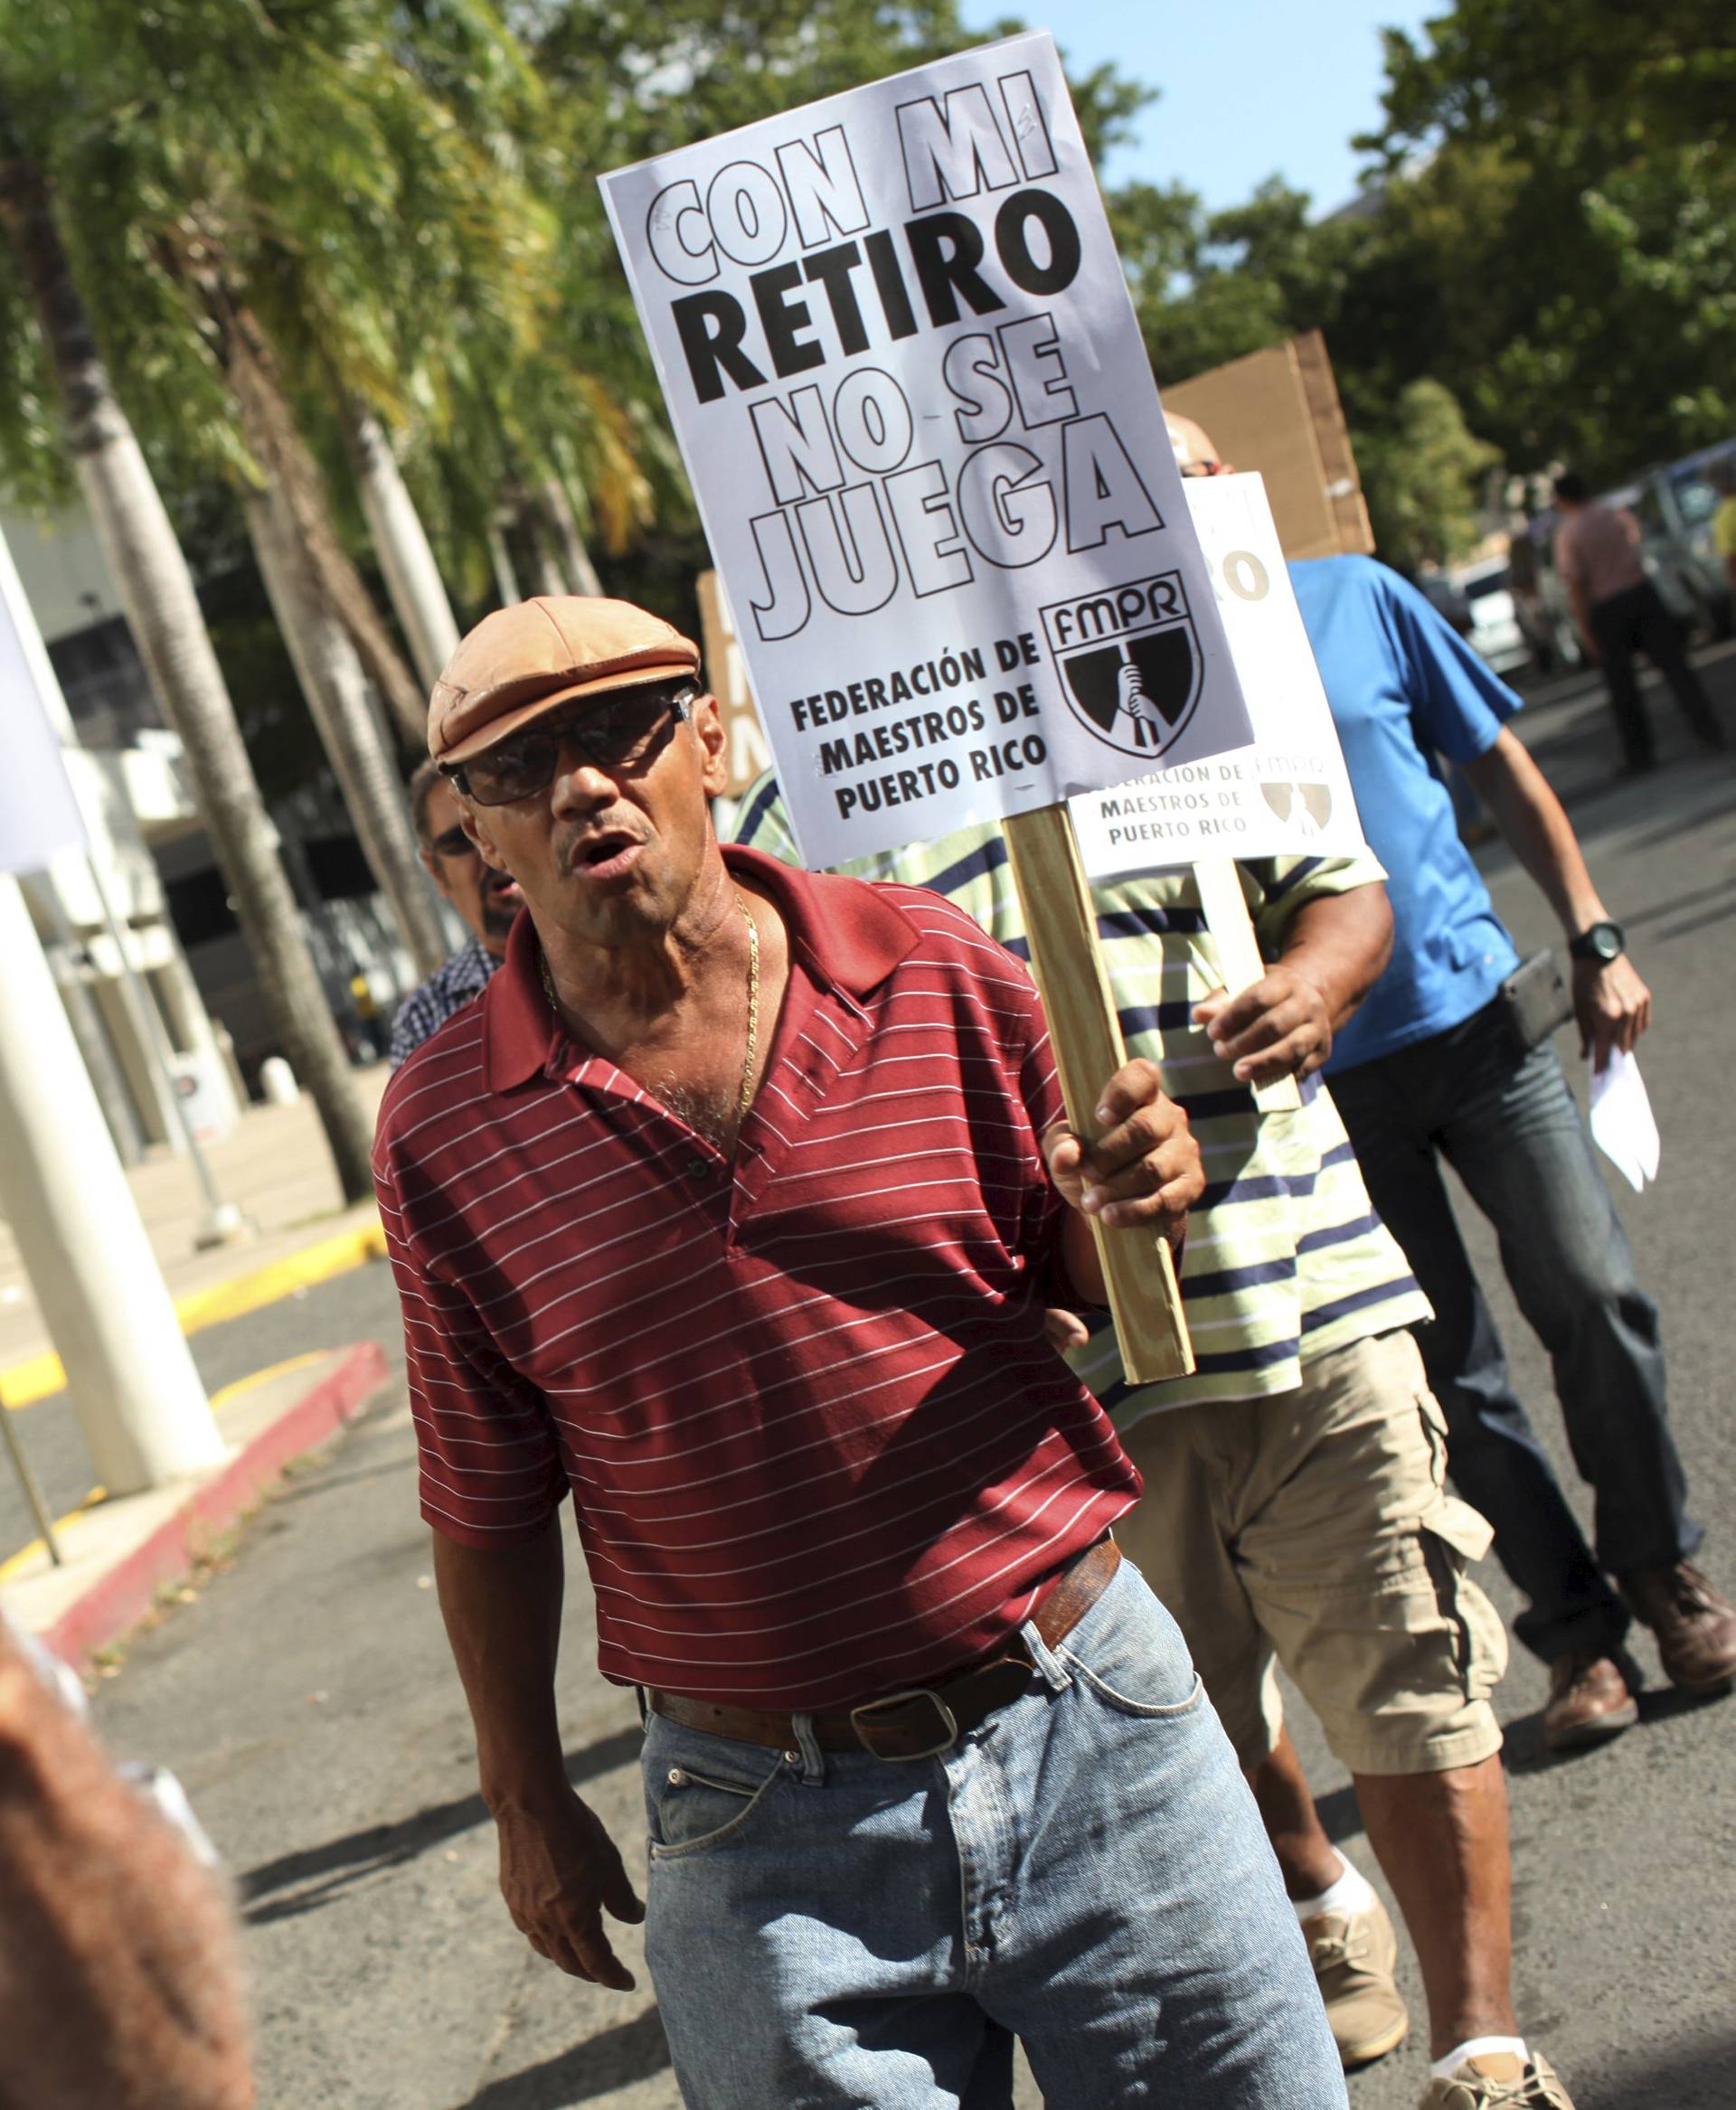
[64,648,1736,2110]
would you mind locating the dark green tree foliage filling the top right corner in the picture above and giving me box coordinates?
[1364,0,1736,476]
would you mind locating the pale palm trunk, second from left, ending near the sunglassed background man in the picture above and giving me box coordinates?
[247,494,451,977]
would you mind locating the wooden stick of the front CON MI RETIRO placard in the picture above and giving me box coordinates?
[1002,806,1194,1384]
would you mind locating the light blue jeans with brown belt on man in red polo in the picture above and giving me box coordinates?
[644,1561,1345,2110]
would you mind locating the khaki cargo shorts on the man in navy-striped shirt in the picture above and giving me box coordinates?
[1116,1332,1506,1773]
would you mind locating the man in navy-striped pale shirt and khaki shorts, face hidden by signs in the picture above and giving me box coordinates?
[734,777,1567,2110]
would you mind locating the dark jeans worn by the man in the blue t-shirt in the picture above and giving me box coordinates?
[1331,1003,1700,1661]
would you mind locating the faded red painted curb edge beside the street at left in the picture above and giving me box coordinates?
[40,1340,386,1669]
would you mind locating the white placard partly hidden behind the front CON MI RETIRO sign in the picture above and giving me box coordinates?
[1073,475,1364,880]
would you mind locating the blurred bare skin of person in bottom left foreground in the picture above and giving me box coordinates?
[0,1612,253,2110]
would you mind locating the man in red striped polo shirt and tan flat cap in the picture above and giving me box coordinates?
[375,599,1344,2110]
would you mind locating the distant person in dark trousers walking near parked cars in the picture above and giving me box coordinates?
[1554,468,1728,777]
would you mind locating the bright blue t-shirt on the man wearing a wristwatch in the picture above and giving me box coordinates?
[1288,557,1519,1072]
